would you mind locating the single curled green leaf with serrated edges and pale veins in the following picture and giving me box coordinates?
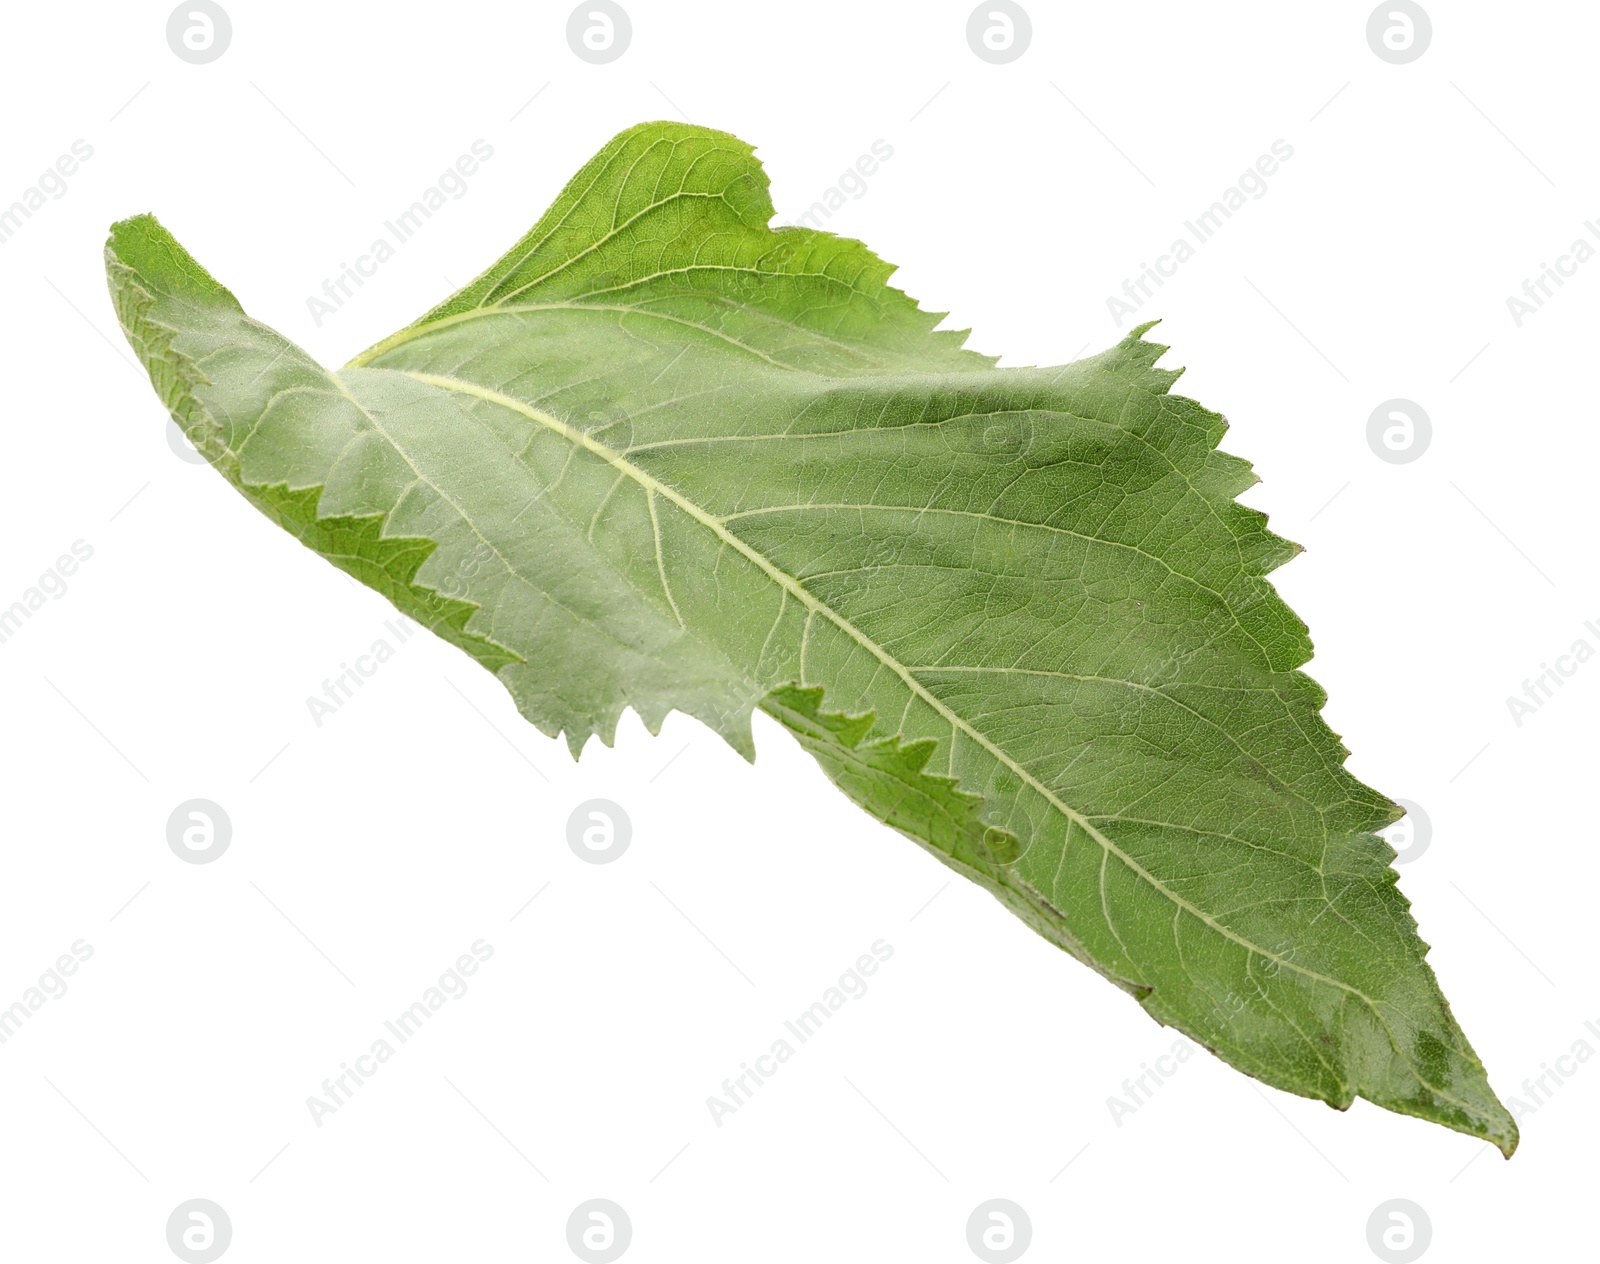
[106,123,1517,1154]
